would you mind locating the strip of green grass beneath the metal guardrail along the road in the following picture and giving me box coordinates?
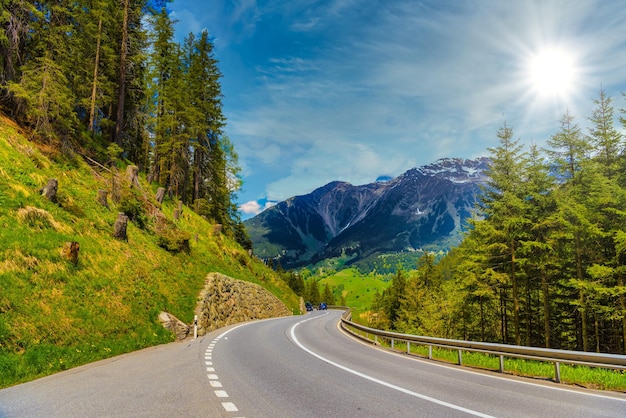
[346,331,626,392]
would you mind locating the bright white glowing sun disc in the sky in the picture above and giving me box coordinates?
[528,48,576,99]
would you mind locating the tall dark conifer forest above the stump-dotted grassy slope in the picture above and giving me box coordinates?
[0,0,251,248]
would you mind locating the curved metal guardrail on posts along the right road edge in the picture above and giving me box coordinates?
[333,306,626,383]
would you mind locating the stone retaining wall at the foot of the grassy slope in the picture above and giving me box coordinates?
[195,273,291,335]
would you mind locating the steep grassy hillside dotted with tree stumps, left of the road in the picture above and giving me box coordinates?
[0,118,298,387]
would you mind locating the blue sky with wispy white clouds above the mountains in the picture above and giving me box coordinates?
[169,0,626,219]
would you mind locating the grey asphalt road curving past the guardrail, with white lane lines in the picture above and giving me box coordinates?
[0,311,626,417]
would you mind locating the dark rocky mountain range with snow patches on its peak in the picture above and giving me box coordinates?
[244,157,489,268]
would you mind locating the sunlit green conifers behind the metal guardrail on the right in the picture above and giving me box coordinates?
[370,90,626,354]
